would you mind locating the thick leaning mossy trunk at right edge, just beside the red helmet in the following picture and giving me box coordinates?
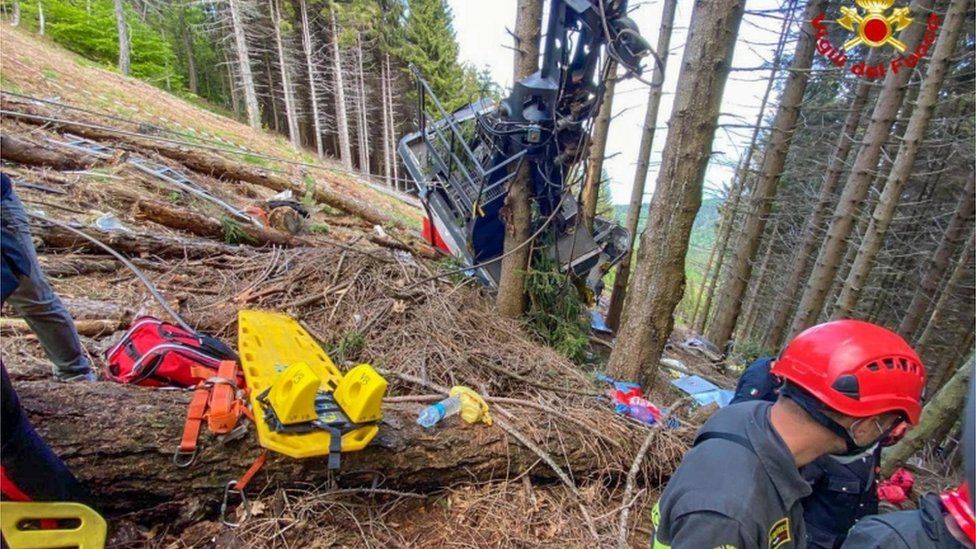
[881,355,974,477]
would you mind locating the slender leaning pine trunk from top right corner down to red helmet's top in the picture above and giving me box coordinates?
[832,0,969,318]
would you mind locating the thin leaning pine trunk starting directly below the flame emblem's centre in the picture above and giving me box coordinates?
[764,57,880,349]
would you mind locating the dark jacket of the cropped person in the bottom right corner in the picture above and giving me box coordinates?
[842,494,963,549]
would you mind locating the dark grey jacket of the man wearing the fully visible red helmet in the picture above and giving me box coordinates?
[653,401,810,549]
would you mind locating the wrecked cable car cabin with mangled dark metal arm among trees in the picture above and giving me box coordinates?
[397,0,650,289]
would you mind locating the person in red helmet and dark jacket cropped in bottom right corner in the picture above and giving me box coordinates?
[843,483,976,549]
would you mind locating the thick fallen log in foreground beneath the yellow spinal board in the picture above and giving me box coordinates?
[14,377,673,522]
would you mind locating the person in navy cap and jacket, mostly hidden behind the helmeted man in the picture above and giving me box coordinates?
[731,357,905,549]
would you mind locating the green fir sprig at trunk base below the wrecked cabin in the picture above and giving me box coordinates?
[525,253,590,363]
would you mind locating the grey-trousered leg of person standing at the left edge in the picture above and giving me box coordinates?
[0,194,94,380]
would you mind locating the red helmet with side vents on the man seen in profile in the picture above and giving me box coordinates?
[771,320,925,425]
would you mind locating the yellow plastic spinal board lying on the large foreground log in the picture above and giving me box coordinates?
[237,311,386,458]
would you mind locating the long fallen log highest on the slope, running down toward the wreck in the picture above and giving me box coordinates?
[0,99,396,229]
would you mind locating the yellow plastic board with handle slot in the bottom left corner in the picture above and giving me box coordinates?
[0,501,108,549]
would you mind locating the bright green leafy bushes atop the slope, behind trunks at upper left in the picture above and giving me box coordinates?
[29,0,182,88]
